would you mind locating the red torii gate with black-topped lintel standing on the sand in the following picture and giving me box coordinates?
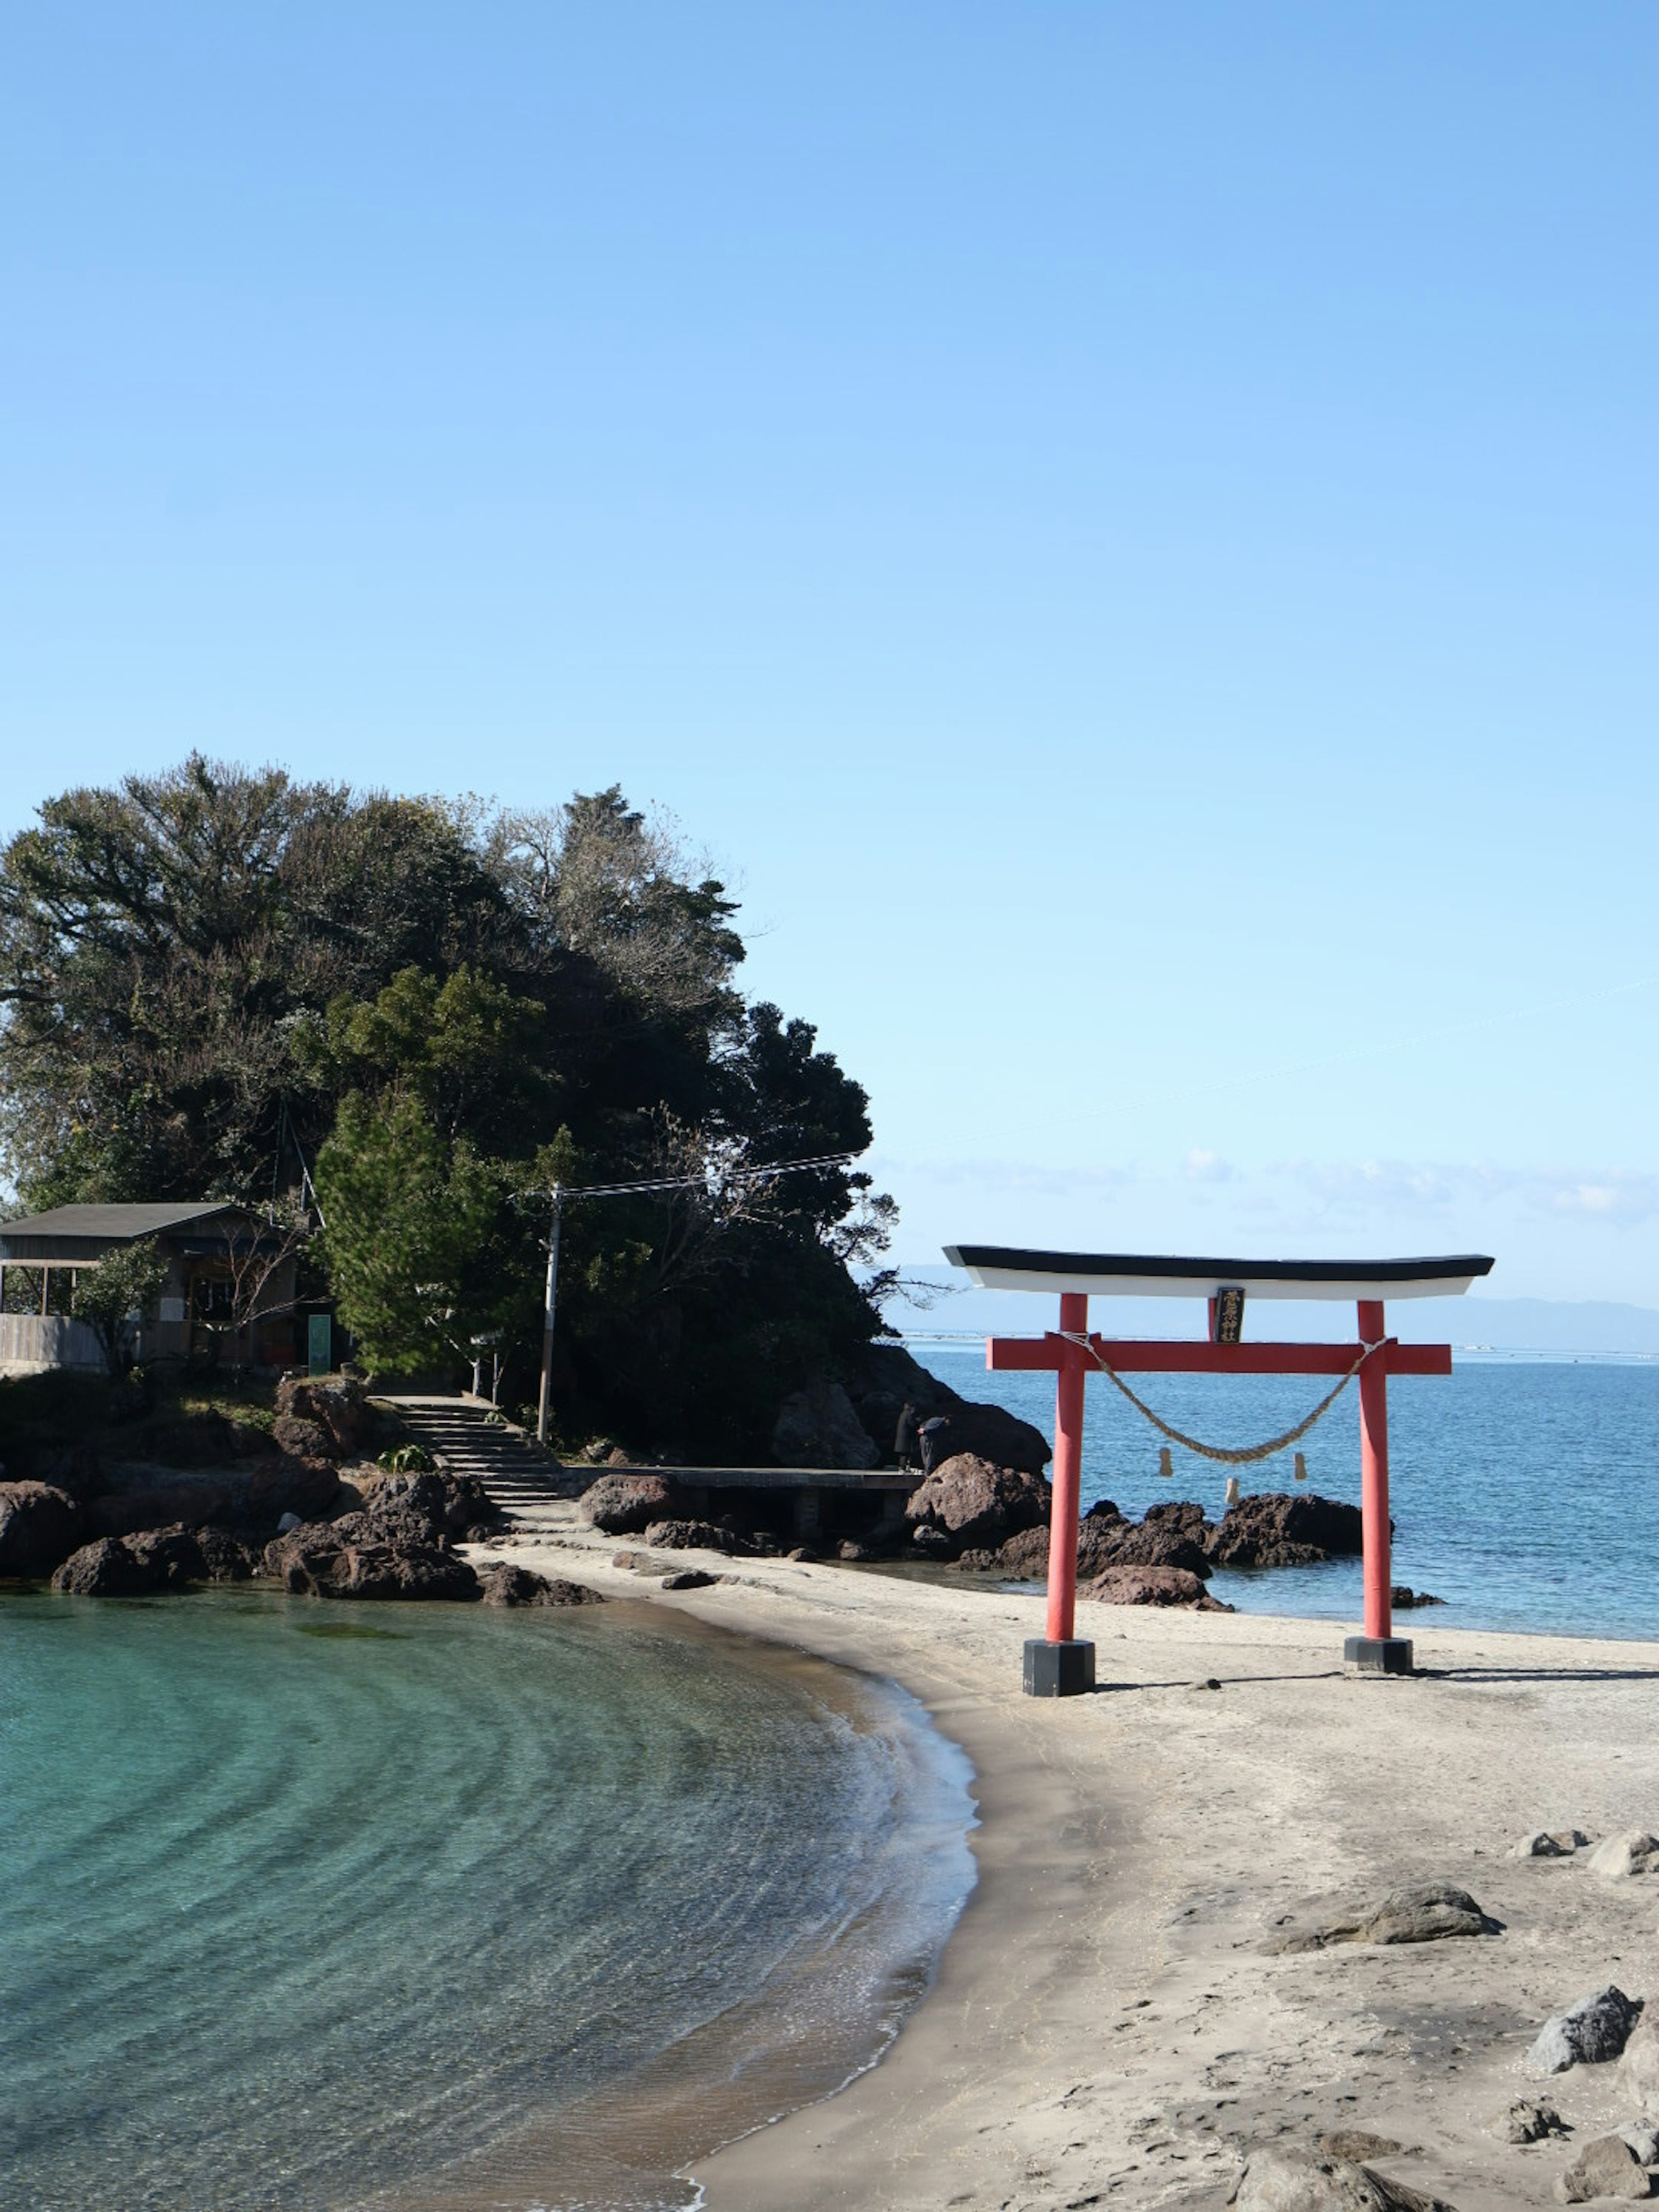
[944,1246,1493,1697]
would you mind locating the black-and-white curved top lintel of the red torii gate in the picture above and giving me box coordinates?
[944,1246,1493,1298]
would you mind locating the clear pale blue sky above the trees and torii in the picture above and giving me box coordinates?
[0,0,1659,1305]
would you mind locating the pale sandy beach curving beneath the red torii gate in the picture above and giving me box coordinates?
[471,1509,1659,2212]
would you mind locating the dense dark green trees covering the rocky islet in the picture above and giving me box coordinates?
[0,759,891,1451]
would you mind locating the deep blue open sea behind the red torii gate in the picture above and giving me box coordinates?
[914,1343,1659,1637]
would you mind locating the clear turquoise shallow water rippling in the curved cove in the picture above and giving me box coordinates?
[0,1592,971,2212]
